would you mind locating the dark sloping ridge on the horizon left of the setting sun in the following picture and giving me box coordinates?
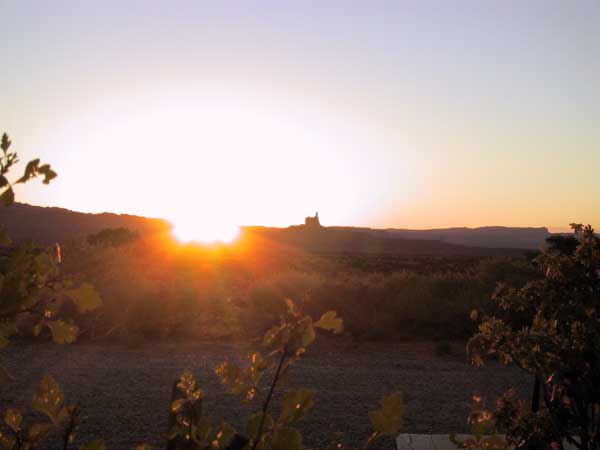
[0,203,170,244]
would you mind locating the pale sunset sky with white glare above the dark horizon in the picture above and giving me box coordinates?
[0,0,600,236]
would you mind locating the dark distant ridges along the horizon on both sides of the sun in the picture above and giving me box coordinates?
[0,203,550,256]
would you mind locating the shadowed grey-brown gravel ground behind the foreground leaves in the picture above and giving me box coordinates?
[0,338,531,449]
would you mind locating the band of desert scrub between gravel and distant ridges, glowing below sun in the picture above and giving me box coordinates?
[48,232,535,339]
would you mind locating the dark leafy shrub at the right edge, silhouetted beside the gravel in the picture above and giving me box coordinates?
[469,224,600,450]
